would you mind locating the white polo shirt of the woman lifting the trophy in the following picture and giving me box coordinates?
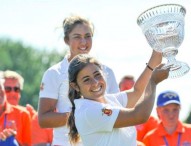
[74,92,136,146]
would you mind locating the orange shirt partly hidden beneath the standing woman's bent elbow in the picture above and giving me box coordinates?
[32,113,53,144]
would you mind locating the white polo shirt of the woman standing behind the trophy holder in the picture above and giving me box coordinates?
[39,56,119,146]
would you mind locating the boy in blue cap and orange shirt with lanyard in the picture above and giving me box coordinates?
[143,91,191,146]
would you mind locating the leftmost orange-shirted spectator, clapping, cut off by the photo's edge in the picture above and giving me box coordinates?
[0,76,31,146]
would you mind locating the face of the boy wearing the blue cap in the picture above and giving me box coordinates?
[157,103,180,127]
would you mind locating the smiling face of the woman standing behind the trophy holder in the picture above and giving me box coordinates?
[65,24,93,59]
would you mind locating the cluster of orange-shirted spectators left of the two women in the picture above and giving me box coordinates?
[0,70,52,146]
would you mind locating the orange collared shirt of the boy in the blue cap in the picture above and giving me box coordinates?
[143,121,191,146]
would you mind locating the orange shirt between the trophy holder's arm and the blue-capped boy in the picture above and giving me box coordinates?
[136,116,159,142]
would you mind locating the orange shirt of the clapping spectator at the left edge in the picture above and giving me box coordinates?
[0,103,31,146]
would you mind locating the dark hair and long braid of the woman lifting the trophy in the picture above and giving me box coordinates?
[67,54,102,143]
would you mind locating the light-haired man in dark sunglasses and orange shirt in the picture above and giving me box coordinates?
[4,70,52,146]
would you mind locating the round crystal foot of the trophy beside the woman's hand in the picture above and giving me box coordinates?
[163,61,190,79]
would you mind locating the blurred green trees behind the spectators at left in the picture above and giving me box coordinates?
[0,39,66,109]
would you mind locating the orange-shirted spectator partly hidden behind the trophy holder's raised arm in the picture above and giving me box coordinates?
[119,75,158,142]
